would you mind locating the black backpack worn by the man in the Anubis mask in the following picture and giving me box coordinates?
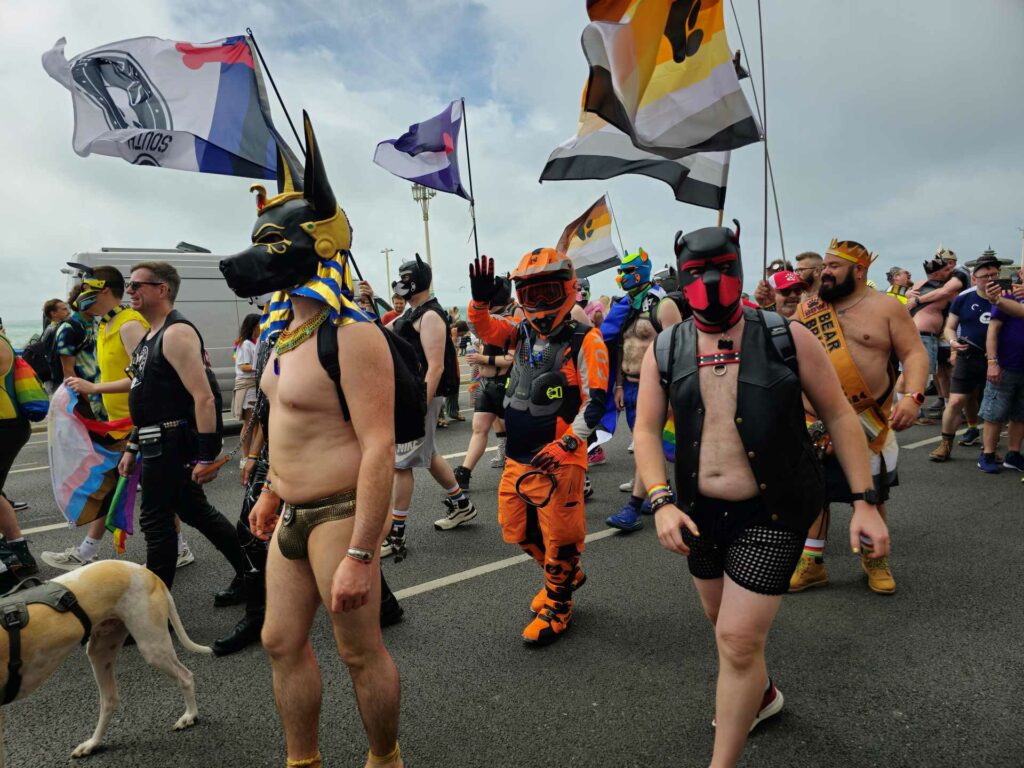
[316,323,427,443]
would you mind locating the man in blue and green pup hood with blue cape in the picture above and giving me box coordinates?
[601,248,682,532]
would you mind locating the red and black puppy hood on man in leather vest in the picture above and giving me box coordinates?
[676,219,743,333]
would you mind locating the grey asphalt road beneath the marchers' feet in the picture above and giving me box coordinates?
[6,391,1024,768]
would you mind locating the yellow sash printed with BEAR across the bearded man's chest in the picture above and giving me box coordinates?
[797,296,893,453]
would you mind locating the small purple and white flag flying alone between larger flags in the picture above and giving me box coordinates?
[374,101,470,200]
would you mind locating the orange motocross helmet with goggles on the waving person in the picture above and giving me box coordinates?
[512,248,575,336]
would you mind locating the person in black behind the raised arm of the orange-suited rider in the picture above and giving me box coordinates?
[455,276,515,490]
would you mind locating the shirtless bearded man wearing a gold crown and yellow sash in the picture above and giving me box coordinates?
[790,240,928,594]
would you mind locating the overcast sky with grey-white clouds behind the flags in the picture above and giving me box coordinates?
[0,0,1024,324]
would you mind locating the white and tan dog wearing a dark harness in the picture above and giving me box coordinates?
[0,560,213,768]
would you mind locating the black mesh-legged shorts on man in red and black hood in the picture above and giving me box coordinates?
[682,497,807,595]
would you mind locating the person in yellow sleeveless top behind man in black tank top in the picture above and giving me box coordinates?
[41,266,150,570]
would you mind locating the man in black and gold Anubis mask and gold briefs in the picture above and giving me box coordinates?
[220,116,402,768]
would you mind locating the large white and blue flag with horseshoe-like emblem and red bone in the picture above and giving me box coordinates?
[43,35,286,179]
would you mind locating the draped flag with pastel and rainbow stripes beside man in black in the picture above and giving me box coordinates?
[47,385,137,554]
